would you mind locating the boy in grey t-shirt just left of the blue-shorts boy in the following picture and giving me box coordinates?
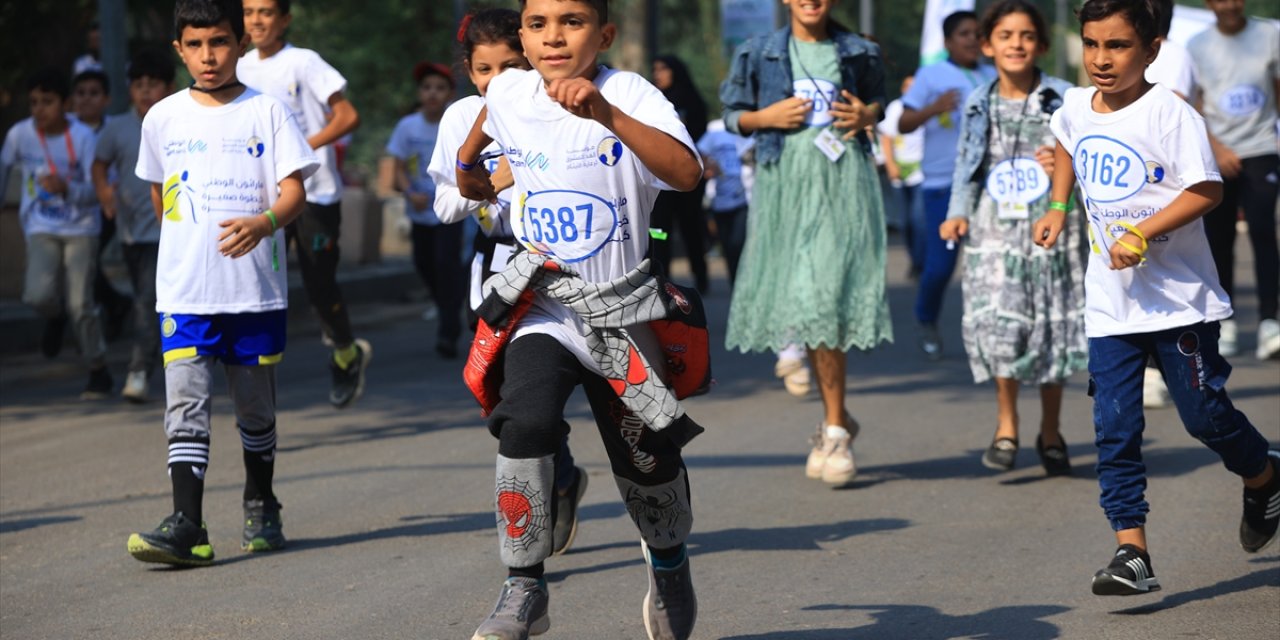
[92,51,174,402]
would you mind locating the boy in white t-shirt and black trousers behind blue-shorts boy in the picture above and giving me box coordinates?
[237,0,374,408]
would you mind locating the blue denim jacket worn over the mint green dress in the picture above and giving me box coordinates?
[719,27,884,165]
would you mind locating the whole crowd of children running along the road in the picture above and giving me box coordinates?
[0,0,1280,640]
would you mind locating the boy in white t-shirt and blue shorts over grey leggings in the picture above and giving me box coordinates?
[128,0,319,566]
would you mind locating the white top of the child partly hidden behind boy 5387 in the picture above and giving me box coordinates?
[428,96,515,238]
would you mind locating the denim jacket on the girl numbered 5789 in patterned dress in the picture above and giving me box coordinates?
[947,73,1075,219]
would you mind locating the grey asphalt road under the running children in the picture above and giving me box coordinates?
[0,241,1280,640]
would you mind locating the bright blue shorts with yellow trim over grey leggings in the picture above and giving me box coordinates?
[160,308,287,366]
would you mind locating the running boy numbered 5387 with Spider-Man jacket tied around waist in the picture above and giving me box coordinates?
[457,0,701,640]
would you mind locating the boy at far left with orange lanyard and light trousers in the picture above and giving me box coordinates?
[0,69,111,399]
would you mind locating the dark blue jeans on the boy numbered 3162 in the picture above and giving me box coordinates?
[1089,323,1267,531]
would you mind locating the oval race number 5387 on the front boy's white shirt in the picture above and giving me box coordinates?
[516,191,618,262]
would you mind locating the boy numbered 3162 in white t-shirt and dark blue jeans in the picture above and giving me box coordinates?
[1032,0,1280,595]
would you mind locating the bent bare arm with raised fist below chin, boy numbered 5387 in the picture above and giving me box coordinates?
[547,78,703,191]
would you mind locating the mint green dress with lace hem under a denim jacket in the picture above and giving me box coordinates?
[724,40,893,352]
